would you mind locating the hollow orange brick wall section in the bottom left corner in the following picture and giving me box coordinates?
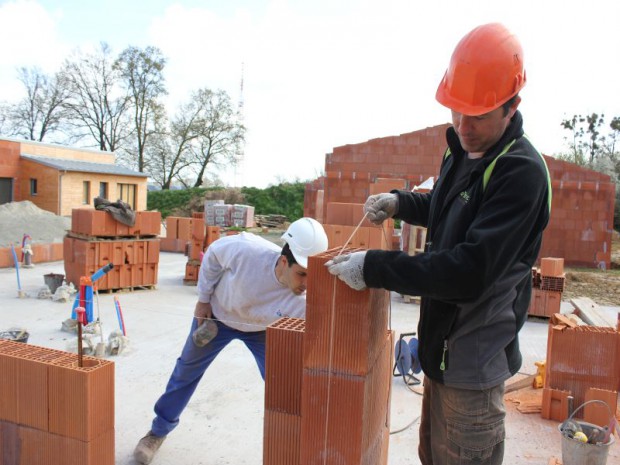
[0,340,115,465]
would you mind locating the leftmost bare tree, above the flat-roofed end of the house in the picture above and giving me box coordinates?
[6,67,68,142]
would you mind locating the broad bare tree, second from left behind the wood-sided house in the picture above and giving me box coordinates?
[61,42,130,152]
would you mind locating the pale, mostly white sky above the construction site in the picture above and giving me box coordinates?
[0,0,620,188]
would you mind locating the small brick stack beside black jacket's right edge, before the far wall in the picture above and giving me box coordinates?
[528,257,566,318]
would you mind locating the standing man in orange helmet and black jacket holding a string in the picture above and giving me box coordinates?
[326,24,551,465]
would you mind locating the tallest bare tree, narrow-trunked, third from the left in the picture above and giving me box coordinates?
[114,46,167,172]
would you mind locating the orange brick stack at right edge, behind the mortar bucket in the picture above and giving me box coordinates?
[541,313,620,426]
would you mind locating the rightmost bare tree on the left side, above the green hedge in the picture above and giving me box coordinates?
[183,88,245,187]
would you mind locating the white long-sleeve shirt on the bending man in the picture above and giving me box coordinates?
[198,232,306,332]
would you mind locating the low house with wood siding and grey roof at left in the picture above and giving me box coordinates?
[0,139,148,216]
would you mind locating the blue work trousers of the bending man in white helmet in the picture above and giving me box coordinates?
[151,318,265,436]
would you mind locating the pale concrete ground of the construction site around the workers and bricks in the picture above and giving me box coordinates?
[0,252,620,465]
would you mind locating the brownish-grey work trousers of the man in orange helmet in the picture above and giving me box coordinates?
[418,378,506,465]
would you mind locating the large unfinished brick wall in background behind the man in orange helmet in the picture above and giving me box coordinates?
[304,124,615,269]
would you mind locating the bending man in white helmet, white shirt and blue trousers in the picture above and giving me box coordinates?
[134,218,327,464]
